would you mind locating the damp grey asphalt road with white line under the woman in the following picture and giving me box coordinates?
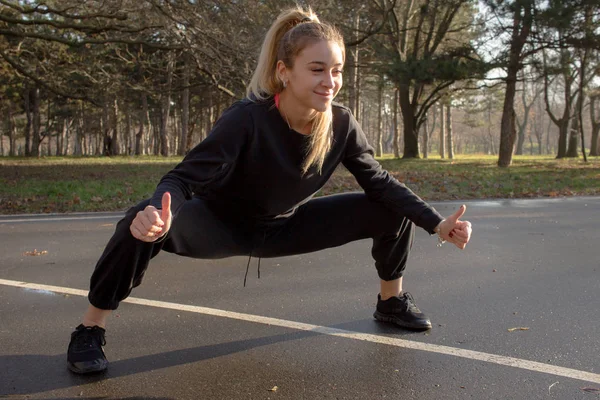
[0,197,600,400]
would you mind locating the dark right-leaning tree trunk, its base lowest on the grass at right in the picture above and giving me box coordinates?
[498,1,533,167]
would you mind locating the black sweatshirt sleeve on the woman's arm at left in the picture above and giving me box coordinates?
[150,103,252,215]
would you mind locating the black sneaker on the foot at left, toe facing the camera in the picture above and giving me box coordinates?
[67,325,108,374]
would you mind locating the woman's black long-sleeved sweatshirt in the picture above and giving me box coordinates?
[150,98,442,234]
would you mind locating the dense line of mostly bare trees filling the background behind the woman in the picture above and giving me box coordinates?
[0,0,600,167]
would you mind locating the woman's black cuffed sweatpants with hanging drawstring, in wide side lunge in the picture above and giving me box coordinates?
[88,193,415,310]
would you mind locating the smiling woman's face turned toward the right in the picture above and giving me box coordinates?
[280,40,344,112]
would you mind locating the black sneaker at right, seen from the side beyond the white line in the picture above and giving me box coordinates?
[373,292,431,330]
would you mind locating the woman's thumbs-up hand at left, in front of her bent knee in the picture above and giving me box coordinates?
[129,192,173,243]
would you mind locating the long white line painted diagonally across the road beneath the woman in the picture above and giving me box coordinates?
[0,279,600,384]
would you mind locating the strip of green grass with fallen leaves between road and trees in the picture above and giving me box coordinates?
[0,155,600,214]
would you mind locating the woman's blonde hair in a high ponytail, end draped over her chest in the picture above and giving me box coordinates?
[246,6,345,175]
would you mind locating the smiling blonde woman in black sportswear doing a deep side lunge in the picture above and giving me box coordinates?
[67,8,471,373]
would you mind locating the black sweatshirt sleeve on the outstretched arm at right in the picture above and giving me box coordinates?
[342,114,443,234]
